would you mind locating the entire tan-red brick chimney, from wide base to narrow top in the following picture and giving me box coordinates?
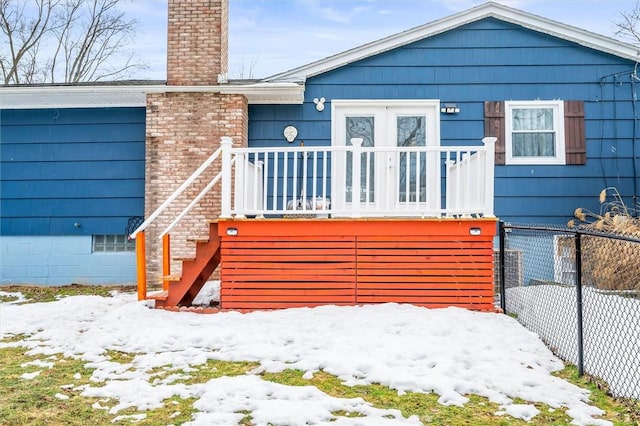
[145,0,248,287]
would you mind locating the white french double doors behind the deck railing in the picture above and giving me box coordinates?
[331,100,440,212]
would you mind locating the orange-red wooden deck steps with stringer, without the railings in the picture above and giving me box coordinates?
[147,222,220,308]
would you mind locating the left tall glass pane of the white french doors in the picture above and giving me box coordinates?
[345,116,375,203]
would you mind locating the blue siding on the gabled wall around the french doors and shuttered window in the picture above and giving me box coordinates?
[249,18,640,223]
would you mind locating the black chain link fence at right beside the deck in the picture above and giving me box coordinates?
[496,223,640,413]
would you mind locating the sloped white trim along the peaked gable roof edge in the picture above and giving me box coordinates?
[264,2,640,82]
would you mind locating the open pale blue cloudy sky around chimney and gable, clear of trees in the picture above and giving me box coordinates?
[126,0,636,80]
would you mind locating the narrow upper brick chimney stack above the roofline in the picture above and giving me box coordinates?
[167,0,229,86]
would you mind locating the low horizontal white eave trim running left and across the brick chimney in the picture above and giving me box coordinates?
[0,83,304,109]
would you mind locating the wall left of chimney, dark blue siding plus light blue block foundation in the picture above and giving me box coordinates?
[0,108,145,285]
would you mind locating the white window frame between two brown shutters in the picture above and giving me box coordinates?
[504,100,566,165]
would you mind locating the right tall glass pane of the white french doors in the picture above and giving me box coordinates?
[396,115,427,203]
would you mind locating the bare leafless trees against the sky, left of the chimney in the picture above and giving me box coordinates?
[0,0,147,84]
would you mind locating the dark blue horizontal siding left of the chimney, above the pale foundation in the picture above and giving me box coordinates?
[0,108,145,235]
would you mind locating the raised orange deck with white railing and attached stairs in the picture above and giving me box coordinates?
[130,137,496,313]
